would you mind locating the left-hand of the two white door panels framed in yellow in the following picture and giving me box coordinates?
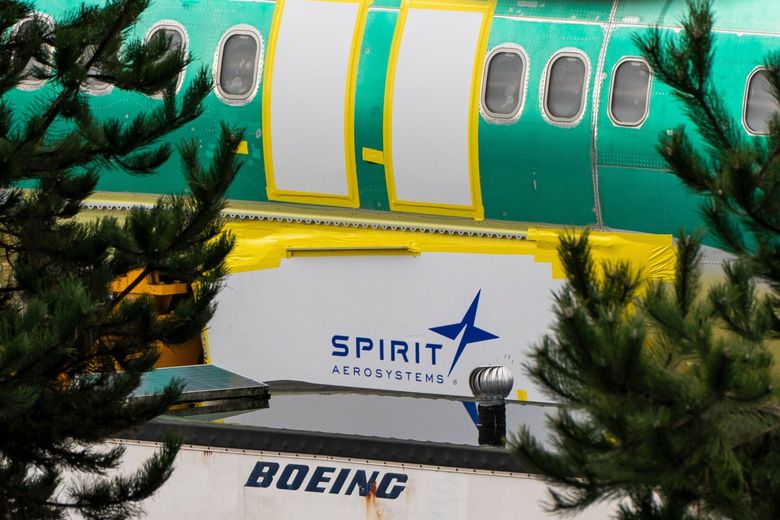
[271,0,358,195]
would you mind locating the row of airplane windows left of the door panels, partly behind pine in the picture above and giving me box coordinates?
[15,15,262,105]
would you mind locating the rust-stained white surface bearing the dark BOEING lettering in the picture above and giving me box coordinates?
[114,443,614,520]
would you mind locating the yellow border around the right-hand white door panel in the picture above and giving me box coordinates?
[382,0,495,220]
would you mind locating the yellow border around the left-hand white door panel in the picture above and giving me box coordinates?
[262,0,371,208]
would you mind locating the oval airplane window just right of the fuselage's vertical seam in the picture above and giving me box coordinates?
[609,59,650,126]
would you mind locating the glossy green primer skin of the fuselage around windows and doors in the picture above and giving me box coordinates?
[9,0,780,240]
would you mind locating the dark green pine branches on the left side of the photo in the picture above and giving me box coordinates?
[0,0,243,518]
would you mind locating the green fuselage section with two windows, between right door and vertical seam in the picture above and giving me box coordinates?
[479,18,603,225]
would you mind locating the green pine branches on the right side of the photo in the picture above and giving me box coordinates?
[513,0,780,520]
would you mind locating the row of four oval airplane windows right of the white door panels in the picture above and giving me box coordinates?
[482,45,780,135]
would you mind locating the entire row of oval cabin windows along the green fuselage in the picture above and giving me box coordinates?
[15,15,779,135]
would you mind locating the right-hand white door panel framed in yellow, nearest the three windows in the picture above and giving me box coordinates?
[392,9,483,206]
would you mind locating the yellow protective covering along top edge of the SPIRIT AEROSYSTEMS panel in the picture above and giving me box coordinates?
[226,221,676,280]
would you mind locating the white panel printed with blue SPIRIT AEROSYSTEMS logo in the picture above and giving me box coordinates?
[209,253,561,401]
